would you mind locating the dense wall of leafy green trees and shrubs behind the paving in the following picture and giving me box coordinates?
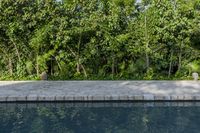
[0,0,200,79]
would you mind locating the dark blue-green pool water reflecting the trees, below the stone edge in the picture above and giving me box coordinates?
[0,103,200,133]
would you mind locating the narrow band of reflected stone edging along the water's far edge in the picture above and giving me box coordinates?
[0,101,200,110]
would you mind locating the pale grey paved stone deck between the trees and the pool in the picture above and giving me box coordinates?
[0,81,200,102]
